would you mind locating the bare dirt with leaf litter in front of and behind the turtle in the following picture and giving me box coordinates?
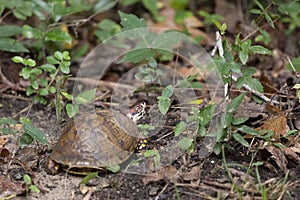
[0,95,300,200]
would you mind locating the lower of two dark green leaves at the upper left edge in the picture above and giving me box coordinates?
[0,38,29,53]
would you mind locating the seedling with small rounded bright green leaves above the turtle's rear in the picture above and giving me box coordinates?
[12,51,71,121]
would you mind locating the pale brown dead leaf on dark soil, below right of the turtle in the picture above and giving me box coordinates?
[142,166,179,185]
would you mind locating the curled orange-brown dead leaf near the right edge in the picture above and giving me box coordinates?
[261,115,290,140]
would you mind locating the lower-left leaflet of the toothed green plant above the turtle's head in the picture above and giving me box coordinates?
[120,48,154,63]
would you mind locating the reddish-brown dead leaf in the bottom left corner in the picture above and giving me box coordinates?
[0,176,25,198]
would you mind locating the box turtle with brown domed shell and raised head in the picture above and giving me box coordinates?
[46,102,146,175]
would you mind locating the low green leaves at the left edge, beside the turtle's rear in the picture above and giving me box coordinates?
[0,117,49,146]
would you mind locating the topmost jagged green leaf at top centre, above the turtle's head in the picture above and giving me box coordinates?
[118,11,147,31]
